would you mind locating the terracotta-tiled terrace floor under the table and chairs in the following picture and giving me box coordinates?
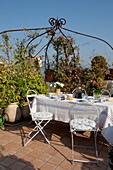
[0,121,110,170]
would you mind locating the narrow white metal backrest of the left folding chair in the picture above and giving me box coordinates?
[26,90,37,114]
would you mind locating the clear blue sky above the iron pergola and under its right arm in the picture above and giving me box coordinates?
[0,0,113,65]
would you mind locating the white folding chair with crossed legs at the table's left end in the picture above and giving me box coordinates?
[24,90,53,146]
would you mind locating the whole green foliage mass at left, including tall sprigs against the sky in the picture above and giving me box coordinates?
[0,33,48,110]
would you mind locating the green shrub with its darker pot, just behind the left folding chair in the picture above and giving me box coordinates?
[16,59,48,118]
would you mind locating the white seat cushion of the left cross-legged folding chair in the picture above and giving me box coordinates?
[33,112,53,120]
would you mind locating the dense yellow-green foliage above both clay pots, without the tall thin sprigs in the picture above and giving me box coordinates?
[0,59,48,109]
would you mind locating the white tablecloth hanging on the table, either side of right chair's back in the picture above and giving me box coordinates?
[32,95,113,145]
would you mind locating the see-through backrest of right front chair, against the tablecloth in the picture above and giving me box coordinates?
[69,102,99,128]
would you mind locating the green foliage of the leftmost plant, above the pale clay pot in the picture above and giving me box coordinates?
[0,65,19,109]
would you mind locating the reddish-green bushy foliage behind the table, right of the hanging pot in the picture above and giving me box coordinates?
[58,57,107,95]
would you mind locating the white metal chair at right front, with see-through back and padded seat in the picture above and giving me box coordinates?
[69,103,99,163]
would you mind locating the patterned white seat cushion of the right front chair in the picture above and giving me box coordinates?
[70,119,96,131]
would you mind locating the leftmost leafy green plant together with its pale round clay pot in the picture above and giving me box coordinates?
[0,64,21,123]
